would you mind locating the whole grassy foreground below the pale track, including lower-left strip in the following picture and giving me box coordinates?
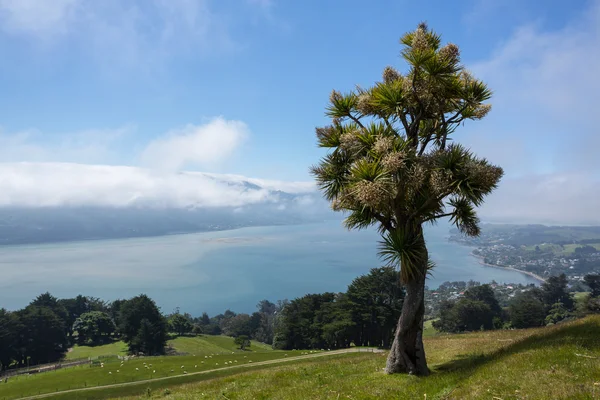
[0,316,600,400]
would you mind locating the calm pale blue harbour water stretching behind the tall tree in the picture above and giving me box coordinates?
[0,221,536,315]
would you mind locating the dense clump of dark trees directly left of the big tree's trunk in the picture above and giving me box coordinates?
[273,267,404,349]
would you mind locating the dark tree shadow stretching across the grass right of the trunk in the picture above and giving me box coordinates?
[434,318,600,375]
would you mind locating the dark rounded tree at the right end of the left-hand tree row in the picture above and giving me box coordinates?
[119,294,167,355]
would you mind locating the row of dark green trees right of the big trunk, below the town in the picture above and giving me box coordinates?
[433,274,600,332]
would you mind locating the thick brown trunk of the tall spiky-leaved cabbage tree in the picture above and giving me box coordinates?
[385,236,429,376]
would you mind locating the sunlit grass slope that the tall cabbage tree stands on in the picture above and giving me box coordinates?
[120,316,600,400]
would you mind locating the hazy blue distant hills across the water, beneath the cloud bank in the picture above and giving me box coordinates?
[0,174,340,245]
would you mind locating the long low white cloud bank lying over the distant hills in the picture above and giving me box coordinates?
[0,163,309,208]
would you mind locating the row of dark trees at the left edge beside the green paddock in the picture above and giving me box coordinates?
[0,293,167,371]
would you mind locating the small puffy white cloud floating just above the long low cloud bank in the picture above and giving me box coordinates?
[141,117,249,171]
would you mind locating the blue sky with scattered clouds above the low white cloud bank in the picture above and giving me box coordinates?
[0,0,600,223]
